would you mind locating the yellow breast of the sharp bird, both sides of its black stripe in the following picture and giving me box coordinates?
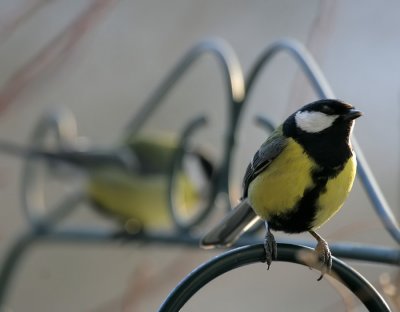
[248,139,356,229]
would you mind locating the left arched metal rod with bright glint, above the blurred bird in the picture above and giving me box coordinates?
[124,38,245,223]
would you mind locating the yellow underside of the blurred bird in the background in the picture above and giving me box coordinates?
[87,169,201,230]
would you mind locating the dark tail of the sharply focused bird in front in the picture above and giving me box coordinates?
[200,200,259,248]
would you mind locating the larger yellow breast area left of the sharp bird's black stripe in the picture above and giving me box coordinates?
[248,138,315,220]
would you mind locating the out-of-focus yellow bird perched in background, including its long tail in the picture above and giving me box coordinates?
[0,134,214,233]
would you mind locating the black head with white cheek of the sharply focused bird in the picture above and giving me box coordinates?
[283,99,361,165]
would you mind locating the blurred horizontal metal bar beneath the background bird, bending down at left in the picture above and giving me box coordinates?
[0,227,400,307]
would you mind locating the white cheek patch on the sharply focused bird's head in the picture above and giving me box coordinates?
[295,111,338,133]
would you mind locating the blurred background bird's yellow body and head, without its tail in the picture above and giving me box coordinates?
[86,135,214,232]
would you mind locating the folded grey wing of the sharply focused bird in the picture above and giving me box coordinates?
[242,126,287,199]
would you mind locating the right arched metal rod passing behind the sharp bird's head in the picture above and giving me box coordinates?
[242,40,400,244]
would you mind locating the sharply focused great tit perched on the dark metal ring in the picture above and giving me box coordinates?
[201,99,362,280]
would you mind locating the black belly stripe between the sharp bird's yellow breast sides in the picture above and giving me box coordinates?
[267,166,344,233]
